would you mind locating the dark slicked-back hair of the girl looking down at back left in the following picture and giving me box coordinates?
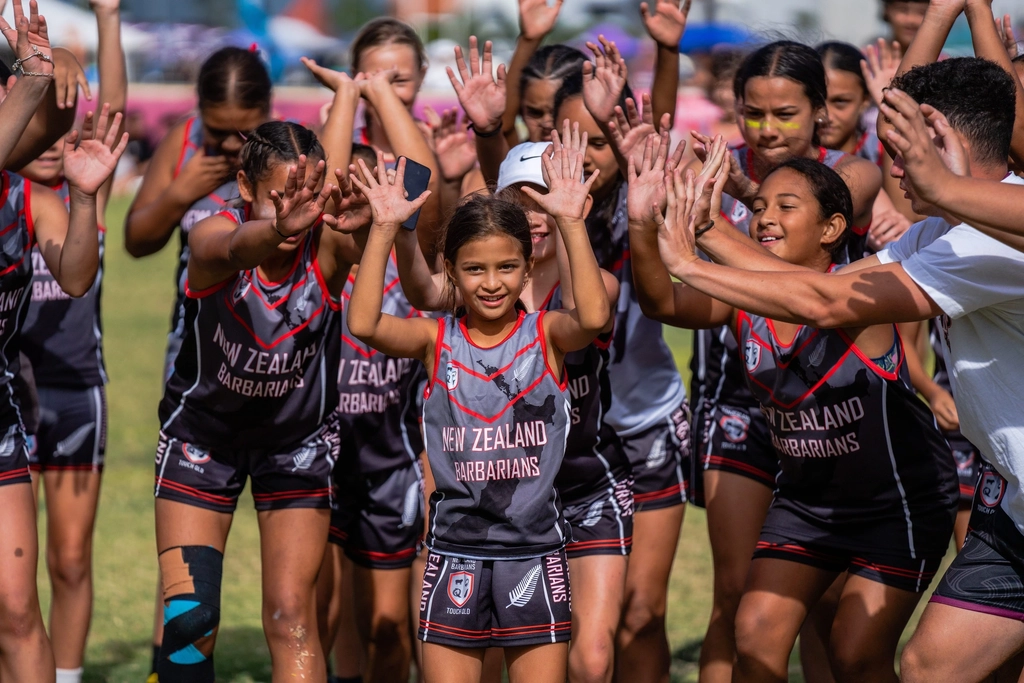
[196,47,272,113]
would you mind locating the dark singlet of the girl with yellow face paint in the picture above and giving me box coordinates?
[690,145,866,417]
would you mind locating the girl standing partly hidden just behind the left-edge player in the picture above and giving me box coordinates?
[20,0,128,681]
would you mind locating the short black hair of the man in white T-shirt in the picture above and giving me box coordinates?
[892,57,1017,163]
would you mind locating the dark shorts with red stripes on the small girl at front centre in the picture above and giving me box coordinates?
[419,550,572,647]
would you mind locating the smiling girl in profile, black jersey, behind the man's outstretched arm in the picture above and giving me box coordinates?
[630,139,956,681]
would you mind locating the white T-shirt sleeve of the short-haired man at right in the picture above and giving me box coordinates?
[894,224,1024,318]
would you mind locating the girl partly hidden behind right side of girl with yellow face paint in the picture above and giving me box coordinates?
[816,42,910,253]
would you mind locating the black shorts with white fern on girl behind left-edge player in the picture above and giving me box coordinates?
[29,386,106,472]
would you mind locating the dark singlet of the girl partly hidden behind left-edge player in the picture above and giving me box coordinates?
[22,180,106,389]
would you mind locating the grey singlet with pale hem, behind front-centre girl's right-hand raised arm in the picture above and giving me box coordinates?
[587,182,686,436]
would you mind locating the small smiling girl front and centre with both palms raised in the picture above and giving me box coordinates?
[348,137,609,683]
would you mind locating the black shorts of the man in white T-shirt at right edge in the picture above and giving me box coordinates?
[931,493,1024,622]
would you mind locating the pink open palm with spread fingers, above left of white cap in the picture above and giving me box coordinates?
[447,36,506,133]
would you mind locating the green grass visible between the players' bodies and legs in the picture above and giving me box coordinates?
[39,200,950,683]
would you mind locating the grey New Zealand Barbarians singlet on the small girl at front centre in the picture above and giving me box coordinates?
[423,310,571,560]
